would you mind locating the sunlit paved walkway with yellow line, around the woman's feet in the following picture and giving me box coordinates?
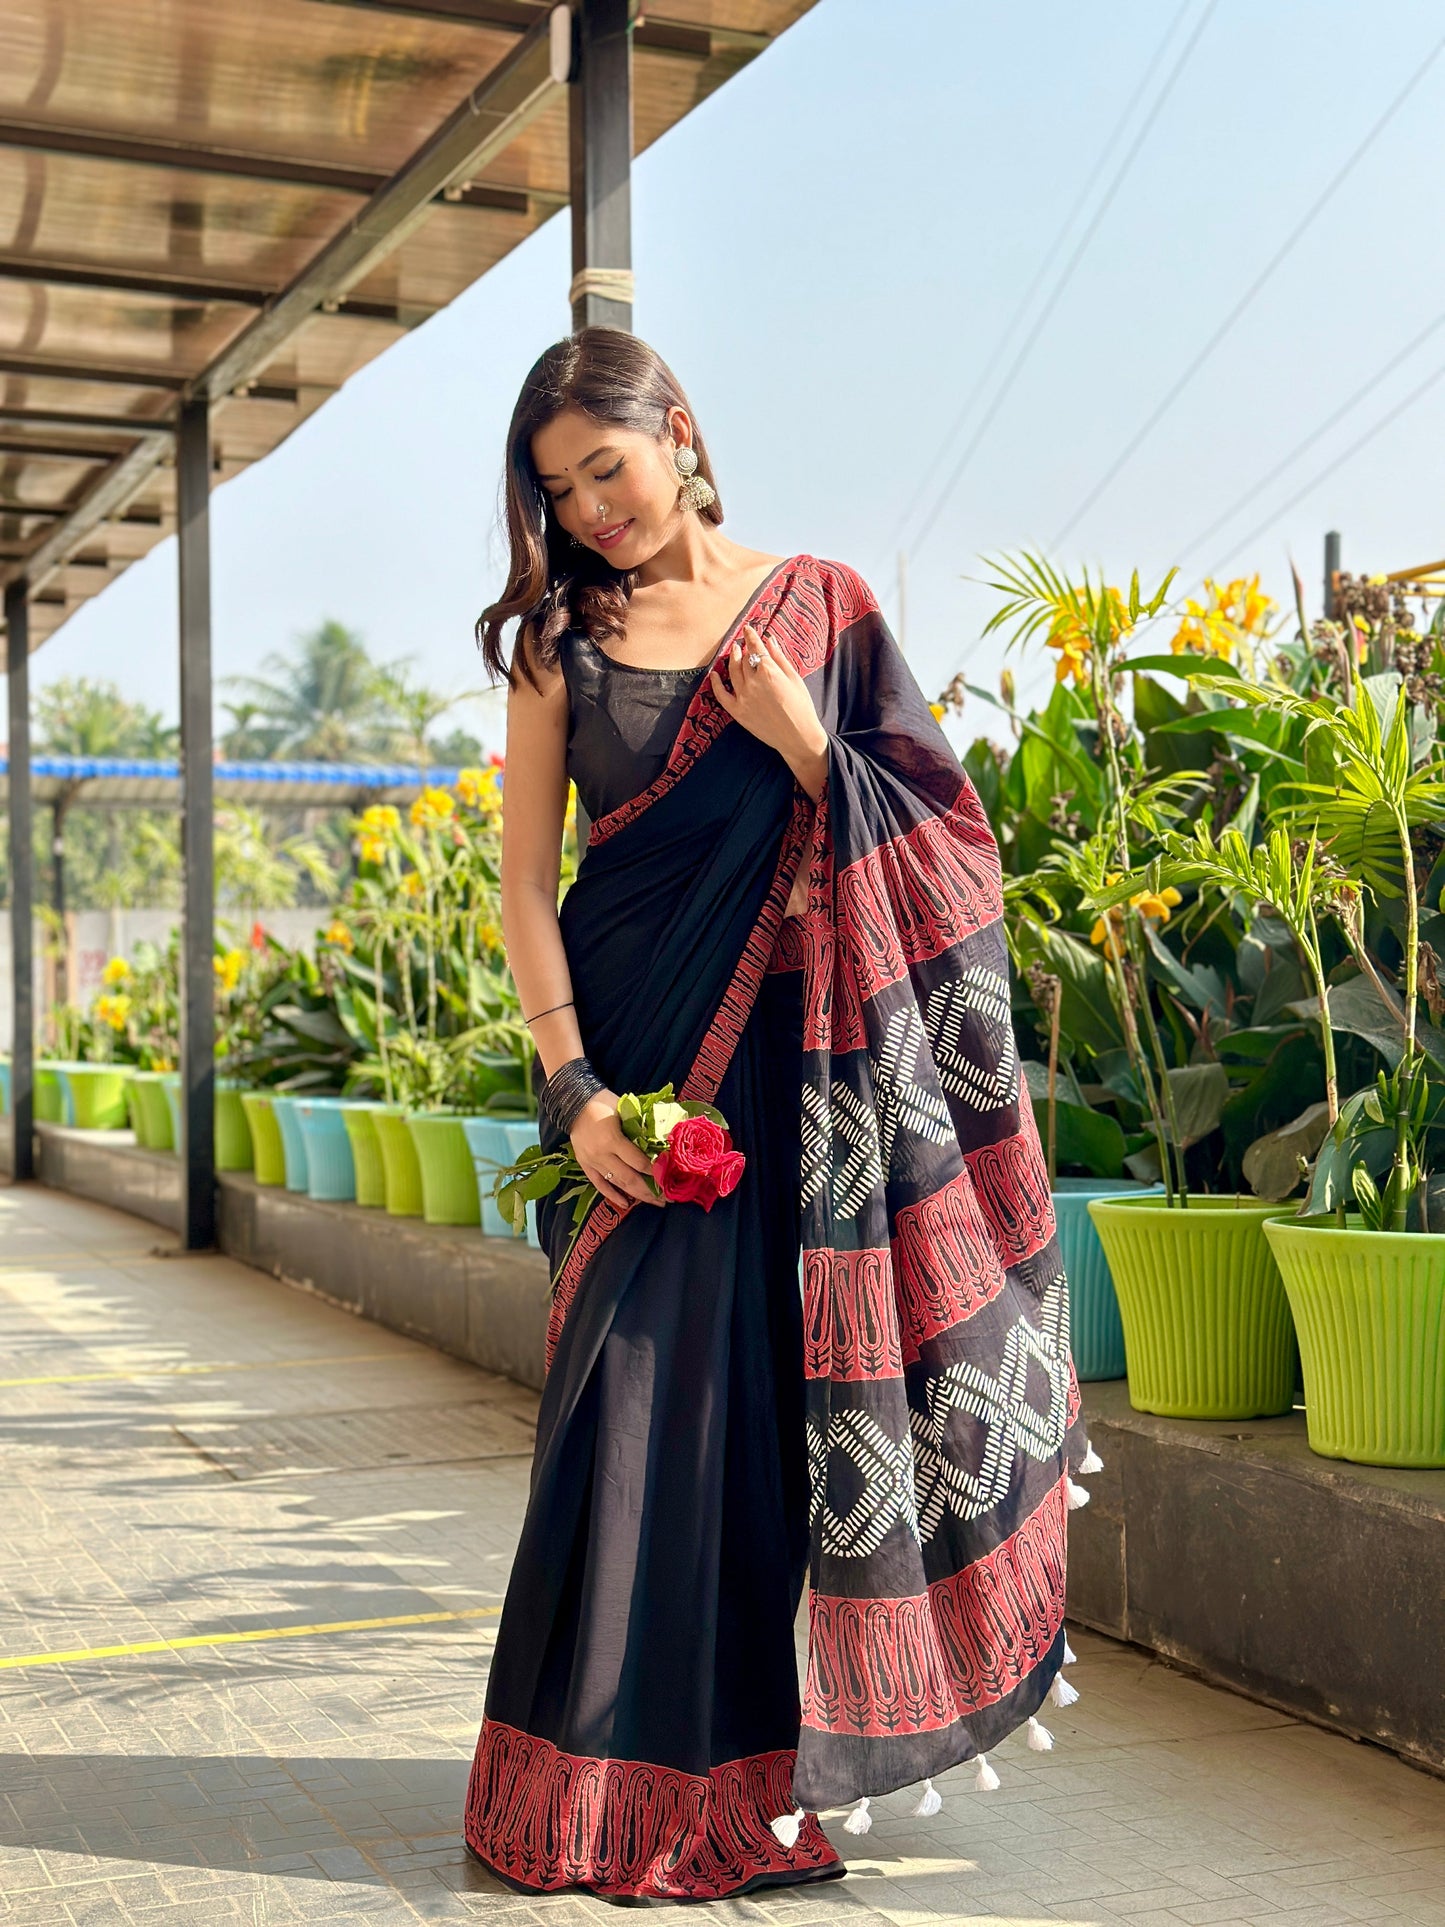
[0,1187,1445,1927]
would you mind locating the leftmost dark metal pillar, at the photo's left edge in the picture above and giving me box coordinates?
[6,582,35,1179]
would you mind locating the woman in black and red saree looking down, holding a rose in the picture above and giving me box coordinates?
[466,328,1085,1902]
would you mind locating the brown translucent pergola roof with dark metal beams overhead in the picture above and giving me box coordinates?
[0,0,813,651]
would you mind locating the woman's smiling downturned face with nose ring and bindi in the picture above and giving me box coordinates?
[532,409,692,570]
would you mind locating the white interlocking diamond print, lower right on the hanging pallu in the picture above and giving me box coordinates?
[909,1276,1069,1545]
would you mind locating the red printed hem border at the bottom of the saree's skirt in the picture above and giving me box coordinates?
[466,1719,838,1900]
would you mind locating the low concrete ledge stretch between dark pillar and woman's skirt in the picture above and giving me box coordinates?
[220,1172,551,1391]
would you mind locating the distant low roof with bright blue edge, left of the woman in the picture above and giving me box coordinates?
[0,755,470,809]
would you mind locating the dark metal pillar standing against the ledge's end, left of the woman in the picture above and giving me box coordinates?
[175,399,216,1251]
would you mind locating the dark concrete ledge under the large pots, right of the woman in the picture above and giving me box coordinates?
[1069,1382,1445,1771]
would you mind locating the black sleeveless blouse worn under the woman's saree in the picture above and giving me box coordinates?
[559,628,715,823]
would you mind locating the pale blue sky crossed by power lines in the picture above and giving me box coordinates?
[35,0,1445,744]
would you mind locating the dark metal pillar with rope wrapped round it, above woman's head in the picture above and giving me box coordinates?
[568,0,636,331]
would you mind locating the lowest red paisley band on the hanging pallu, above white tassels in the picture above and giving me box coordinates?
[803,1478,1067,1738]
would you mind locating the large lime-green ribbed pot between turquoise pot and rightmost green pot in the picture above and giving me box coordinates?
[1089,1193,1295,1418]
